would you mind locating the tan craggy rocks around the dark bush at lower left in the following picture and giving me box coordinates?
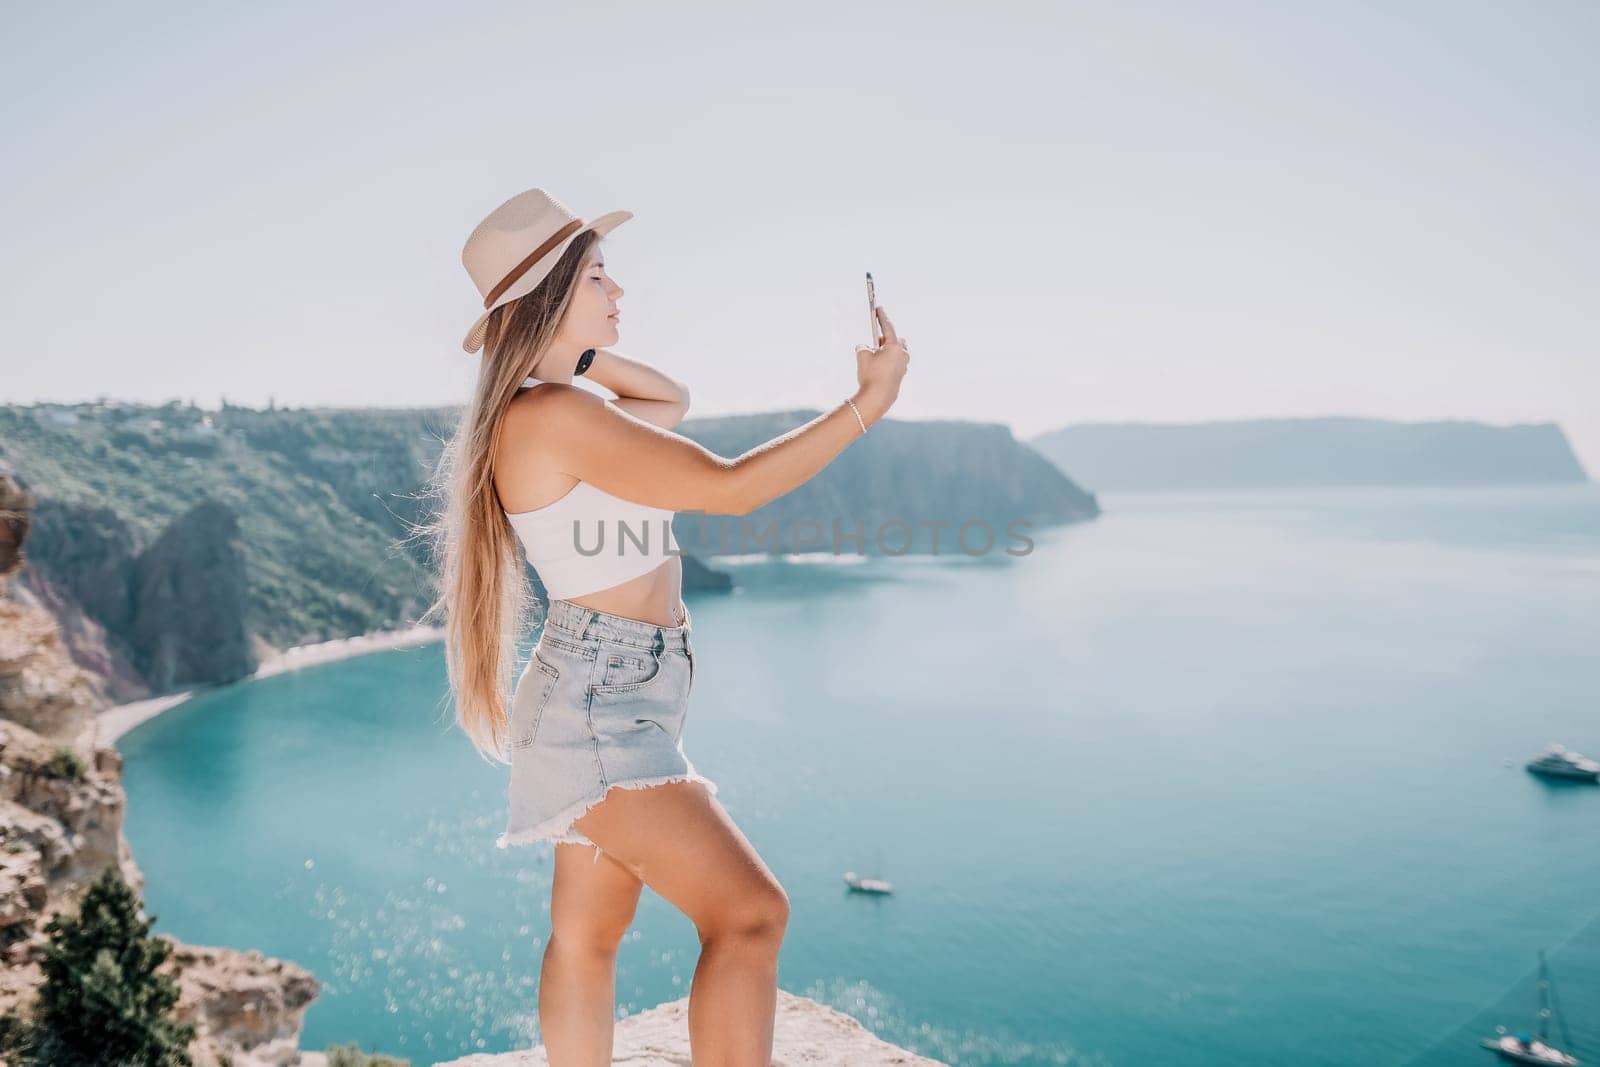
[0,475,318,1067]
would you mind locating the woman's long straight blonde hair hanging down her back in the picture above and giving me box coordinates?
[408,230,598,763]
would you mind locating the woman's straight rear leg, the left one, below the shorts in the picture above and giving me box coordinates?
[539,845,643,1067]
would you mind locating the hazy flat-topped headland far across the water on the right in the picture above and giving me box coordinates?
[1030,418,1589,490]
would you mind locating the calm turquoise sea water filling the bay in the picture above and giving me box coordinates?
[122,485,1600,1065]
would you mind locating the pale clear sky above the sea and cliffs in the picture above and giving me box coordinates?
[0,0,1600,475]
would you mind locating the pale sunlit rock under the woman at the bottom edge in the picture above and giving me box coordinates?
[438,989,944,1067]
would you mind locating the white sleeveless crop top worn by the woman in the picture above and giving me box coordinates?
[506,378,678,600]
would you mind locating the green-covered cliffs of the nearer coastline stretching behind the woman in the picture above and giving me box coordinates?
[0,402,1099,702]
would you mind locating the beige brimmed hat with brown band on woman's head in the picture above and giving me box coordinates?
[461,189,634,352]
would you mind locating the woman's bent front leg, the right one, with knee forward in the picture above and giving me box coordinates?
[576,782,789,1067]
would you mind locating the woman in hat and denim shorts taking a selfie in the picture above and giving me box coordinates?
[429,189,909,1067]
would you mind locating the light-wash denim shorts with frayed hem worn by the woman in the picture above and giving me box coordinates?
[494,600,717,861]
